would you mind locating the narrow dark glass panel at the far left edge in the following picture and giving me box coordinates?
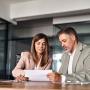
[0,19,8,79]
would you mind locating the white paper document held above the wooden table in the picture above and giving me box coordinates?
[25,70,52,81]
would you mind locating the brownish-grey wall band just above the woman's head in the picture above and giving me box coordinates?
[13,18,53,38]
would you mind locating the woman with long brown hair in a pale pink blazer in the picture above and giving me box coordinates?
[12,33,52,81]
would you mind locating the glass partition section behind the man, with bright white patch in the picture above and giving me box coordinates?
[53,22,90,71]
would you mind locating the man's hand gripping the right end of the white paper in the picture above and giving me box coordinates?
[47,72,61,82]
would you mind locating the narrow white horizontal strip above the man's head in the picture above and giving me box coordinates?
[53,14,90,24]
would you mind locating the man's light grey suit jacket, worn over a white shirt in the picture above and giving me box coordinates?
[60,42,90,81]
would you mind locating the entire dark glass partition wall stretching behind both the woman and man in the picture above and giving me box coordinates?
[0,19,90,79]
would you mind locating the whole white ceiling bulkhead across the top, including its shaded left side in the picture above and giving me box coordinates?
[0,0,90,24]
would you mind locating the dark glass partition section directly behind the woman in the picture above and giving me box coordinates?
[7,19,54,79]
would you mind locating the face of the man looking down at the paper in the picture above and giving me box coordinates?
[59,33,76,53]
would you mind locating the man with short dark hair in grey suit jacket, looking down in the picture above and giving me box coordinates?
[48,27,90,82]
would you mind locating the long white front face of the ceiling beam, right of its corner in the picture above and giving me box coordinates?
[10,0,90,20]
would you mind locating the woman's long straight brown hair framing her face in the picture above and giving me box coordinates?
[31,33,49,66]
